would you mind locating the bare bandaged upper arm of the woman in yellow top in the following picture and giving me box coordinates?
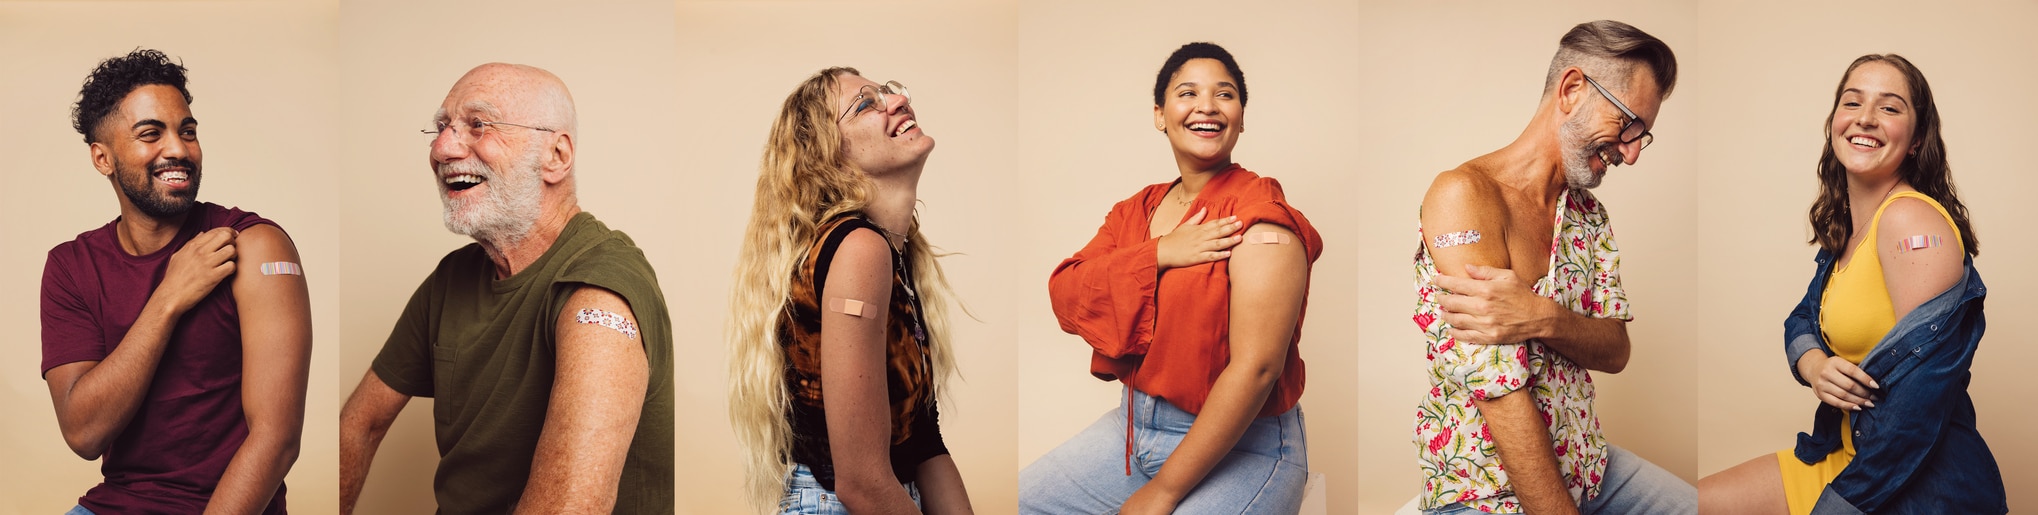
[1875,197,1967,320]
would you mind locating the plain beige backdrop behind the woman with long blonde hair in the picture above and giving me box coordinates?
[666,2,1033,513]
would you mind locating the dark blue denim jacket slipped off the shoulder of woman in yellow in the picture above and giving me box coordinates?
[1783,250,2009,513]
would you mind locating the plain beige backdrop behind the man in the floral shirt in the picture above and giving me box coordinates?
[1333,2,1720,513]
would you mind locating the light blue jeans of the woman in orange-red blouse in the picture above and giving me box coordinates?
[1019,391,1308,513]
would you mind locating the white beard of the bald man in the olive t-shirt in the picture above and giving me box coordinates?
[436,145,544,246]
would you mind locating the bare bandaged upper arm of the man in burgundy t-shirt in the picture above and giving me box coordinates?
[232,226,312,448]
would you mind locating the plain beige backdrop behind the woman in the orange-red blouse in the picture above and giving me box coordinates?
[1009,2,1361,513]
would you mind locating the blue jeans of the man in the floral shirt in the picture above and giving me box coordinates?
[1423,446,1698,515]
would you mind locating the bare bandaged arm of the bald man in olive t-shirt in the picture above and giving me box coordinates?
[518,285,650,513]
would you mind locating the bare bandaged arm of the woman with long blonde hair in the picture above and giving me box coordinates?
[821,230,915,513]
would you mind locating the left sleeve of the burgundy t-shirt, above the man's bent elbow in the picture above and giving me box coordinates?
[43,242,110,375]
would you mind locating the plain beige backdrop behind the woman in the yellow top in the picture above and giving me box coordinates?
[1687,2,2038,513]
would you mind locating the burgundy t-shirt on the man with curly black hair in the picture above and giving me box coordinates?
[43,202,283,513]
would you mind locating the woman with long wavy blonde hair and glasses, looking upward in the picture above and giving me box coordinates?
[728,67,970,513]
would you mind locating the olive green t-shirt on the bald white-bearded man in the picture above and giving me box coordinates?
[371,212,673,513]
